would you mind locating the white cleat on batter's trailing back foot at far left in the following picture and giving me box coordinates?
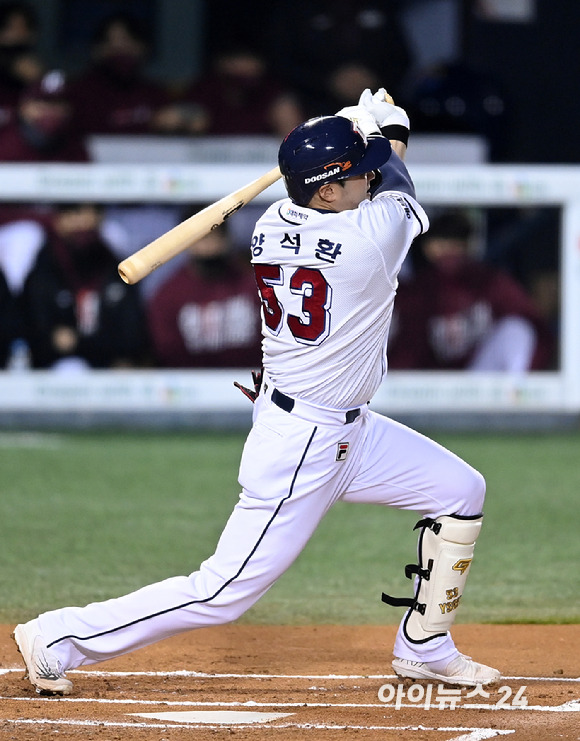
[12,620,72,695]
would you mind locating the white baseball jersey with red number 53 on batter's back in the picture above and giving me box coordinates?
[252,191,428,409]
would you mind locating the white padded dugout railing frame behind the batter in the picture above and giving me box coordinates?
[0,162,580,428]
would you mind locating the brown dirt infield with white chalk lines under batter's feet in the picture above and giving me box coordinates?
[0,625,580,741]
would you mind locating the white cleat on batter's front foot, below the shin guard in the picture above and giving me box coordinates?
[393,654,501,687]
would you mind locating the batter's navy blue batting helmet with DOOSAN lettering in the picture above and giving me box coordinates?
[278,116,391,206]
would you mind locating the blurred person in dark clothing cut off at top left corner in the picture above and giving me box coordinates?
[0,2,43,129]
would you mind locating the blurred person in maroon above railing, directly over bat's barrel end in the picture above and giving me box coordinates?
[68,12,169,134]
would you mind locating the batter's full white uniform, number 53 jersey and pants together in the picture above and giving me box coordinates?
[29,147,485,680]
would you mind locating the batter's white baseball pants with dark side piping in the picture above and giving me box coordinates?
[39,394,485,670]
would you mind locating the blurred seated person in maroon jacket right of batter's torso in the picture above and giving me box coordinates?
[389,211,553,372]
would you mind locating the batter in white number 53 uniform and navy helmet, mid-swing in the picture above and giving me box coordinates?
[14,89,500,694]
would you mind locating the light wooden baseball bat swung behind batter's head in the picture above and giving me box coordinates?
[118,167,282,284]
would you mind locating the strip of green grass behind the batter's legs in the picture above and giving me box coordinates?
[0,433,580,624]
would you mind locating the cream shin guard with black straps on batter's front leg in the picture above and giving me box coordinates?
[383,515,483,643]
